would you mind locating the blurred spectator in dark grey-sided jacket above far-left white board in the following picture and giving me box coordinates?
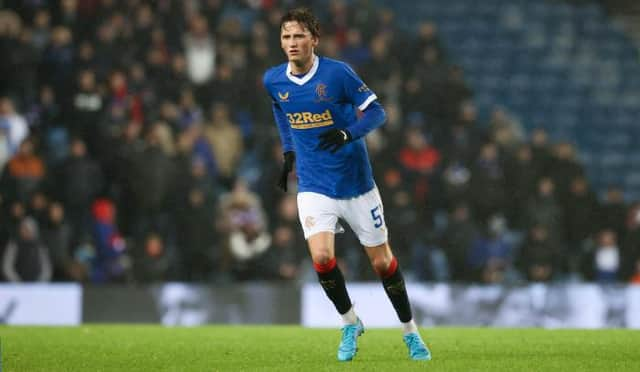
[2,217,52,282]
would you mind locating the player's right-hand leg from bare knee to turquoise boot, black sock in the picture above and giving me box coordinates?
[365,242,431,360]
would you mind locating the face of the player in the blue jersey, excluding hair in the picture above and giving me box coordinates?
[280,21,318,66]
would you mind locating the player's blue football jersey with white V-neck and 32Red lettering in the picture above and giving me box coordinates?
[264,56,377,199]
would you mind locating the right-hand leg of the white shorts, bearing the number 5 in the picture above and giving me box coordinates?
[341,187,388,247]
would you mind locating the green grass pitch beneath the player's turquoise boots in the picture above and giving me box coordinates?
[0,325,640,372]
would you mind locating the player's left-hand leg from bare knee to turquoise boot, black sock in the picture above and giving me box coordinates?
[307,232,364,361]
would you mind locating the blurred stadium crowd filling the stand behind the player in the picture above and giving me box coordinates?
[0,0,640,283]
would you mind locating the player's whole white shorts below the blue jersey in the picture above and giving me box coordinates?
[298,187,388,247]
